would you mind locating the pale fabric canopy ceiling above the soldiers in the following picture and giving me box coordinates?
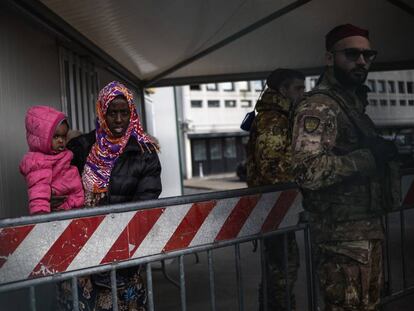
[41,0,414,85]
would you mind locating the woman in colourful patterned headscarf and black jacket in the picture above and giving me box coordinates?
[59,81,161,311]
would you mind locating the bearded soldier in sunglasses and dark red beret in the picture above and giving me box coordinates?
[292,24,398,311]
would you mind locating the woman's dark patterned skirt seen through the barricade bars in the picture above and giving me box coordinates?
[57,267,147,311]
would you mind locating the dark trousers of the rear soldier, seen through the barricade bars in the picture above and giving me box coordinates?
[259,232,299,311]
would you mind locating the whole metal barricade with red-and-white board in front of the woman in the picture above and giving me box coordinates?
[0,184,314,310]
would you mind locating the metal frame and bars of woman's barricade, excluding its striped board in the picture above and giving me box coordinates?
[0,184,313,310]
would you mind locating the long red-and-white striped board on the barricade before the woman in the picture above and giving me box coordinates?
[0,190,302,284]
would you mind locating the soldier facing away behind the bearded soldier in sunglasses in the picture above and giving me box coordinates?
[246,69,305,311]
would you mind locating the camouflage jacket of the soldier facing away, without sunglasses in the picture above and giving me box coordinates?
[246,89,293,187]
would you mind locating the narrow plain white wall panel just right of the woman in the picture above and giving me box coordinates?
[145,87,182,197]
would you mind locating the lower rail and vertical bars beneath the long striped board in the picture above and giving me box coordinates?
[14,225,317,311]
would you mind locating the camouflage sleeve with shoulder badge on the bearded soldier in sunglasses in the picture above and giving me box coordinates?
[292,99,375,190]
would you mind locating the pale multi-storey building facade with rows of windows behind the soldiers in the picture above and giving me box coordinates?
[176,70,414,178]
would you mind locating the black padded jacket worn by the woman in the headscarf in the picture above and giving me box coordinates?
[67,131,162,205]
